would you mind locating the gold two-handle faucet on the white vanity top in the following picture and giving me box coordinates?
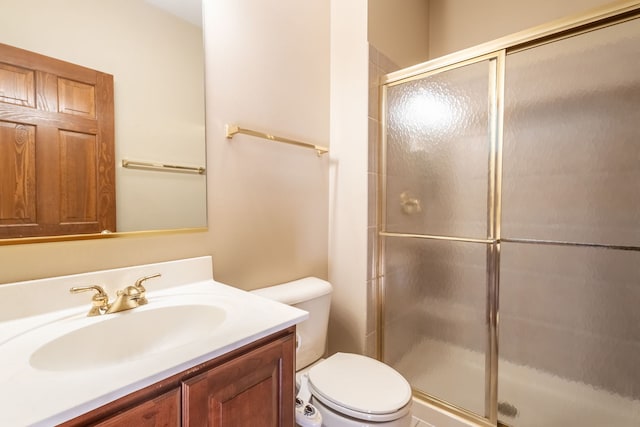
[69,273,160,316]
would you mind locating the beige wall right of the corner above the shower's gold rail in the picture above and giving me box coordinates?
[429,0,611,58]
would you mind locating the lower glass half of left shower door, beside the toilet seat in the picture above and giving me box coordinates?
[384,237,487,415]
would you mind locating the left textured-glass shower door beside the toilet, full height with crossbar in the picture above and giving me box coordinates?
[381,56,497,416]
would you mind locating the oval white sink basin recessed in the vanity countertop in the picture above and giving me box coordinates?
[29,304,227,371]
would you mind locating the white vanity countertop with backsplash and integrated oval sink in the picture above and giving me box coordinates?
[0,257,307,426]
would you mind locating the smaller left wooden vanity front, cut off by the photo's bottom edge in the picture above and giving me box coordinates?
[94,388,180,427]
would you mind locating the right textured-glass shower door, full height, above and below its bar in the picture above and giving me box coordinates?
[498,19,640,427]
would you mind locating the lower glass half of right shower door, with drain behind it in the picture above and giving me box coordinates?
[498,243,640,427]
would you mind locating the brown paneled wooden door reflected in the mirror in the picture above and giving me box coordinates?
[0,44,116,238]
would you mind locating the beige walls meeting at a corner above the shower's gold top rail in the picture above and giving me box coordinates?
[368,0,612,68]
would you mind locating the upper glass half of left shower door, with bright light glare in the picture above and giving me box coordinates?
[386,61,490,238]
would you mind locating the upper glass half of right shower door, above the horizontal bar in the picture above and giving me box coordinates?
[502,20,640,245]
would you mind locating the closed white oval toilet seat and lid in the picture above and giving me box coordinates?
[309,353,411,422]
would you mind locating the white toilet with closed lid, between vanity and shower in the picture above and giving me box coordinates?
[253,277,411,427]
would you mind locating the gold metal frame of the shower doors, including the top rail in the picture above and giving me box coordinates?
[375,1,640,426]
